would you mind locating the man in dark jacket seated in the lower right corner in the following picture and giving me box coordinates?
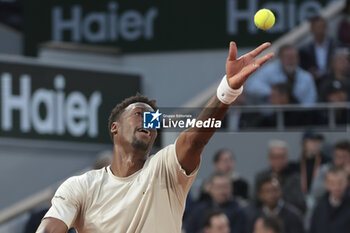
[310,167,350,233]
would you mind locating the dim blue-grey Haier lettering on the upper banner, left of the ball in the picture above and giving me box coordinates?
[51,2,158,42]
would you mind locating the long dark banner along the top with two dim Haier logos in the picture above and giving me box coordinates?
[23,0,330,55]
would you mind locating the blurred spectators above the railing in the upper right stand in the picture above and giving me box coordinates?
[247,13,350,106]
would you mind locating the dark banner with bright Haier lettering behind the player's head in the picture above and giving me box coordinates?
[0,59,140,143]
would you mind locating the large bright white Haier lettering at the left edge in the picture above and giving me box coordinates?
[0,73,102,137]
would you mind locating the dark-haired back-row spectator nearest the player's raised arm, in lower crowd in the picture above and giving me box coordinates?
[199,149,249,200]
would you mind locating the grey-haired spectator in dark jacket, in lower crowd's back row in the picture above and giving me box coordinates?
[255,140,306,212]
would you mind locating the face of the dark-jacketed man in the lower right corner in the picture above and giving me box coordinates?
[325,172,348,200]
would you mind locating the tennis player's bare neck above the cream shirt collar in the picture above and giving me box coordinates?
[111,145,146,177]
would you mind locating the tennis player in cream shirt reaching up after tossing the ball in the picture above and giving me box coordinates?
[37,42,273,233]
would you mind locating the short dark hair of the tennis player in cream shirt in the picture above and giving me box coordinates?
[108,93,158,141]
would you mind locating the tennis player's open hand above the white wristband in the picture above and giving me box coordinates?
[226,42,274,89]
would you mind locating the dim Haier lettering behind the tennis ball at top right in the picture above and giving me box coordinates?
[226,0,331,35]
